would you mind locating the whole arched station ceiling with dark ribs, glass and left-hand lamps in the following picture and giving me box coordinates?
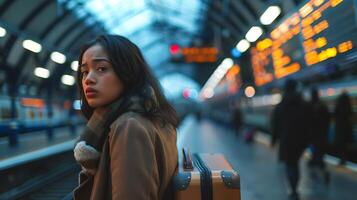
[0,0,306,99]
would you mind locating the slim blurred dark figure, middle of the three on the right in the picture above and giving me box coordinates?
[308,87,330,184]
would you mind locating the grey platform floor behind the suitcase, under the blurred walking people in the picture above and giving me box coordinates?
[178,116,357,200]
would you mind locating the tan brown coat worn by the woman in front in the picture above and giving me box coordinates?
[74,112,178,200]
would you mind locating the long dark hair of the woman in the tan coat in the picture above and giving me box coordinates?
[77,34,178,127]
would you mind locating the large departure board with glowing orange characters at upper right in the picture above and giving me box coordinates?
[251,0,357,86]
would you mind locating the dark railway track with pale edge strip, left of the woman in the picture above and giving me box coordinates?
[0,141,80,200]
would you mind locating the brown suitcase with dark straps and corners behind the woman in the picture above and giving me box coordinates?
[173,151,241,200]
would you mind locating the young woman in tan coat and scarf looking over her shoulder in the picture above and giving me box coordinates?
[73,35,177,200]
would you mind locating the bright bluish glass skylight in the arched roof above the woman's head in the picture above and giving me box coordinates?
[58,0,207,69]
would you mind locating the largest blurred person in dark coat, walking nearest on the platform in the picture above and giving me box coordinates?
[271,80,311,200]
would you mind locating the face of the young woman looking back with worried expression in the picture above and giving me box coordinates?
[80,44,124,108]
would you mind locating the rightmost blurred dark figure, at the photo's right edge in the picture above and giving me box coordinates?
[334,91,353,165]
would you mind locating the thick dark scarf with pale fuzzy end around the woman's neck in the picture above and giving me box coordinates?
[74,87,158,175]
